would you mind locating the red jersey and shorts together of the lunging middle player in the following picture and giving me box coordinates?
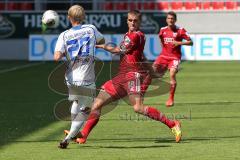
[100,28,151,100]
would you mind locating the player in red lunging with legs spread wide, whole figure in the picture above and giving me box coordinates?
[62,10,181,148]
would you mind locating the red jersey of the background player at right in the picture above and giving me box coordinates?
[159,26,191,59]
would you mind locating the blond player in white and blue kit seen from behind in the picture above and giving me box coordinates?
[54,5,105,149]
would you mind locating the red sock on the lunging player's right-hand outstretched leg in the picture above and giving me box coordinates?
[145,106,175,128]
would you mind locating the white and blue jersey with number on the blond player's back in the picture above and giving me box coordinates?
[55,24,103,86]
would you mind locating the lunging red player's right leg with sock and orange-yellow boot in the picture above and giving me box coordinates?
[129,94,182,143]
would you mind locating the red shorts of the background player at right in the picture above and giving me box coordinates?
[153,56,181,73]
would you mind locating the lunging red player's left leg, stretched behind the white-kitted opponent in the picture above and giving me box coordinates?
[76,91,112,143]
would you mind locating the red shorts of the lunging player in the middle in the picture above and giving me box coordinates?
[101,72,151,99]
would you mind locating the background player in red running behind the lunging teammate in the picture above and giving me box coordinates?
[153,11,193,107]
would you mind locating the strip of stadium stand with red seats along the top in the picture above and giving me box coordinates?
[0,0,240,11]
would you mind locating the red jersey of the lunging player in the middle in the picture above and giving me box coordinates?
[119,31,145,73]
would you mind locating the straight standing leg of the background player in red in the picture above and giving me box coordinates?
[166,68,177,107]
